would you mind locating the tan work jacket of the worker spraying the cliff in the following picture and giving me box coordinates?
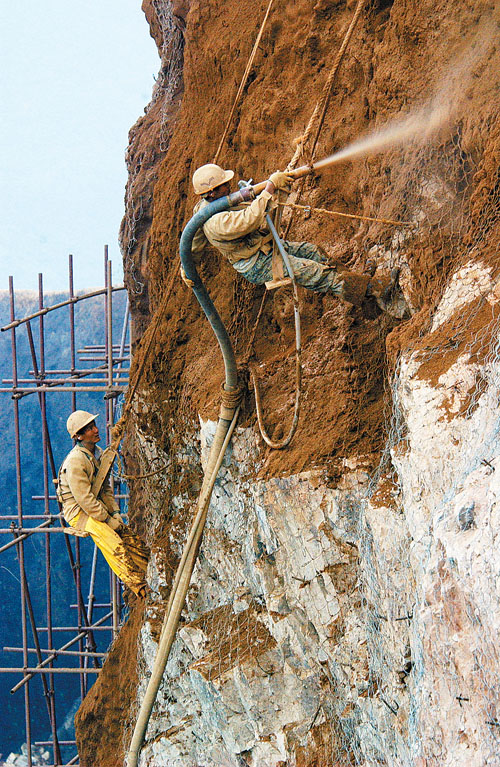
[191,189,272,264]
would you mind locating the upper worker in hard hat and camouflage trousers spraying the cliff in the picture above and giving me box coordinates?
[186,163,408,317]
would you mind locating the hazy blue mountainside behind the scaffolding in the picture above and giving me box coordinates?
[0,291,131,764]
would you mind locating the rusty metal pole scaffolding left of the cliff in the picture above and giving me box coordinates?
[0,246,130,767]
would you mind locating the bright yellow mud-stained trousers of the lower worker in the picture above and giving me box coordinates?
[69,512,149,594]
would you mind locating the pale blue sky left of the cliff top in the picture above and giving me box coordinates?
[0,0,160,291]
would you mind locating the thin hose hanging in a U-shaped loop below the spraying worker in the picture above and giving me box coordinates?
[250,214,302,450]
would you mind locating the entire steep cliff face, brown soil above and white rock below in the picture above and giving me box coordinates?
[77,0,500,767]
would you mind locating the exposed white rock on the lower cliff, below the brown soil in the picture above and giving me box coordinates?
[131,266,500,767]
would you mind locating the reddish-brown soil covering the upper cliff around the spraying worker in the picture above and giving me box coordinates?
[75,0,500,767]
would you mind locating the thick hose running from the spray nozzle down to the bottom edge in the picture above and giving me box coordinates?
[127,192,243,767]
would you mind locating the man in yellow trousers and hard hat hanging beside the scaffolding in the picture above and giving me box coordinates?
[57,410,149,597]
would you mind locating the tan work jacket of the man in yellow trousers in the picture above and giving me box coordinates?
[58,444,120,530]
